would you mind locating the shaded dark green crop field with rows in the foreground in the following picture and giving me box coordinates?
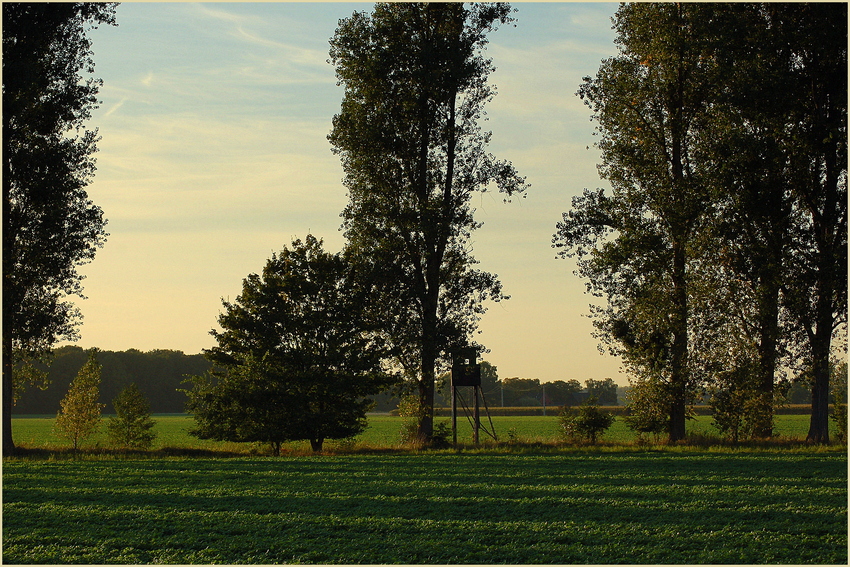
[3,451,848,564]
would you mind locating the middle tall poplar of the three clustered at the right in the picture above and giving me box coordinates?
[696,3,799,437]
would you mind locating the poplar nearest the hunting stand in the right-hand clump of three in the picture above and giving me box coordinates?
[553,3,716,441]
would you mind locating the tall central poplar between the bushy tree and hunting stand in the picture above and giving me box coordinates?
[329,3,526,441]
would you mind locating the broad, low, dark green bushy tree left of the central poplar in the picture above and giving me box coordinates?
[186,235,395,453]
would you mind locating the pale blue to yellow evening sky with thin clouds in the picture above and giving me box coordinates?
[66,2,627,385]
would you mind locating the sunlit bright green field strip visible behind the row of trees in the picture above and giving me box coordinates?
[12,415,809,452]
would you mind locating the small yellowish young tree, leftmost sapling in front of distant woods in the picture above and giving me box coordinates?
[56,349,104,451]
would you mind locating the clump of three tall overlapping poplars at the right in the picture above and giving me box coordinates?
[553,4,847,442]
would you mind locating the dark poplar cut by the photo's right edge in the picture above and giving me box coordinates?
[766,3,847,443]
